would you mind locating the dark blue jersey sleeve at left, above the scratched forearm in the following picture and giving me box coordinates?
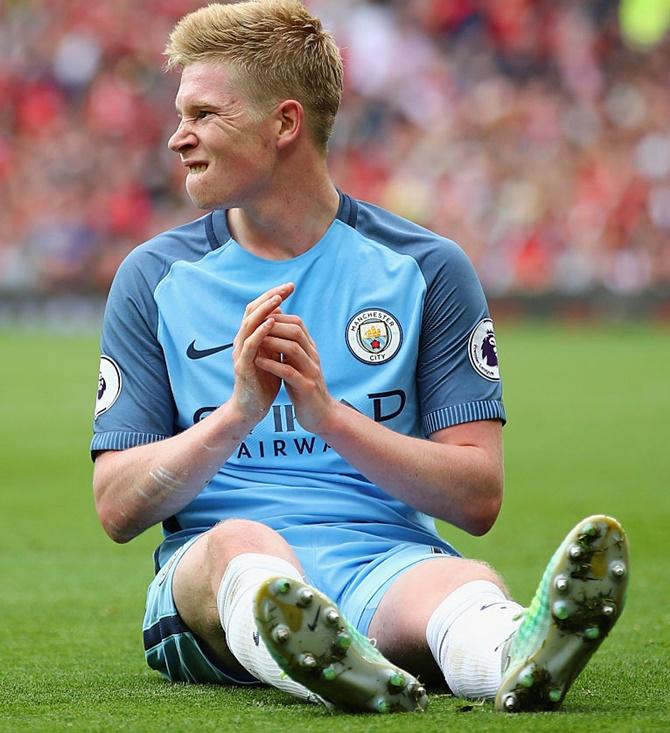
[91,248,176,456]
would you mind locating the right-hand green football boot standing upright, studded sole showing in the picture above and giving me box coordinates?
[495,515,628,712]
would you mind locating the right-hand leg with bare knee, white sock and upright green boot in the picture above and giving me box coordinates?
[370,515,628,712]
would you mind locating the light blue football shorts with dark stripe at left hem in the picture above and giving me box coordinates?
[143,525,460,685]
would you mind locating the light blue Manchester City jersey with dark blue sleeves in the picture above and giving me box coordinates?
[91,194,505,565]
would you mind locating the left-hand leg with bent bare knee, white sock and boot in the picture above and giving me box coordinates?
[173,520,425,712]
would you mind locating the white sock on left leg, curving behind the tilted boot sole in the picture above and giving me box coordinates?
[216,552,320,702]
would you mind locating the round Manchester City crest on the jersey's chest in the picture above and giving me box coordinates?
[346,308,402,364]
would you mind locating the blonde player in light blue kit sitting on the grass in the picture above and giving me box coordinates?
[92,0,627,712]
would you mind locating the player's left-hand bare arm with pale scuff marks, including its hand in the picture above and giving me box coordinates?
[93,283,293,542]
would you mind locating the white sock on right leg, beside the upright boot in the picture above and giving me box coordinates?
[426,580,523,698]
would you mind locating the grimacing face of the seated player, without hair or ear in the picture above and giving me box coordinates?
[168,61,275,209]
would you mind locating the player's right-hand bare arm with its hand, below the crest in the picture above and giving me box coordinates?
[256,315,503,534]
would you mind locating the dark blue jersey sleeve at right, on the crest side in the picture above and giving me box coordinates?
[417,241,506,435]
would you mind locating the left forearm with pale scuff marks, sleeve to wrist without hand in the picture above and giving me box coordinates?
[93,403,252,542]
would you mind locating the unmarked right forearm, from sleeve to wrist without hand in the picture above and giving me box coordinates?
[319,403,503,534]
